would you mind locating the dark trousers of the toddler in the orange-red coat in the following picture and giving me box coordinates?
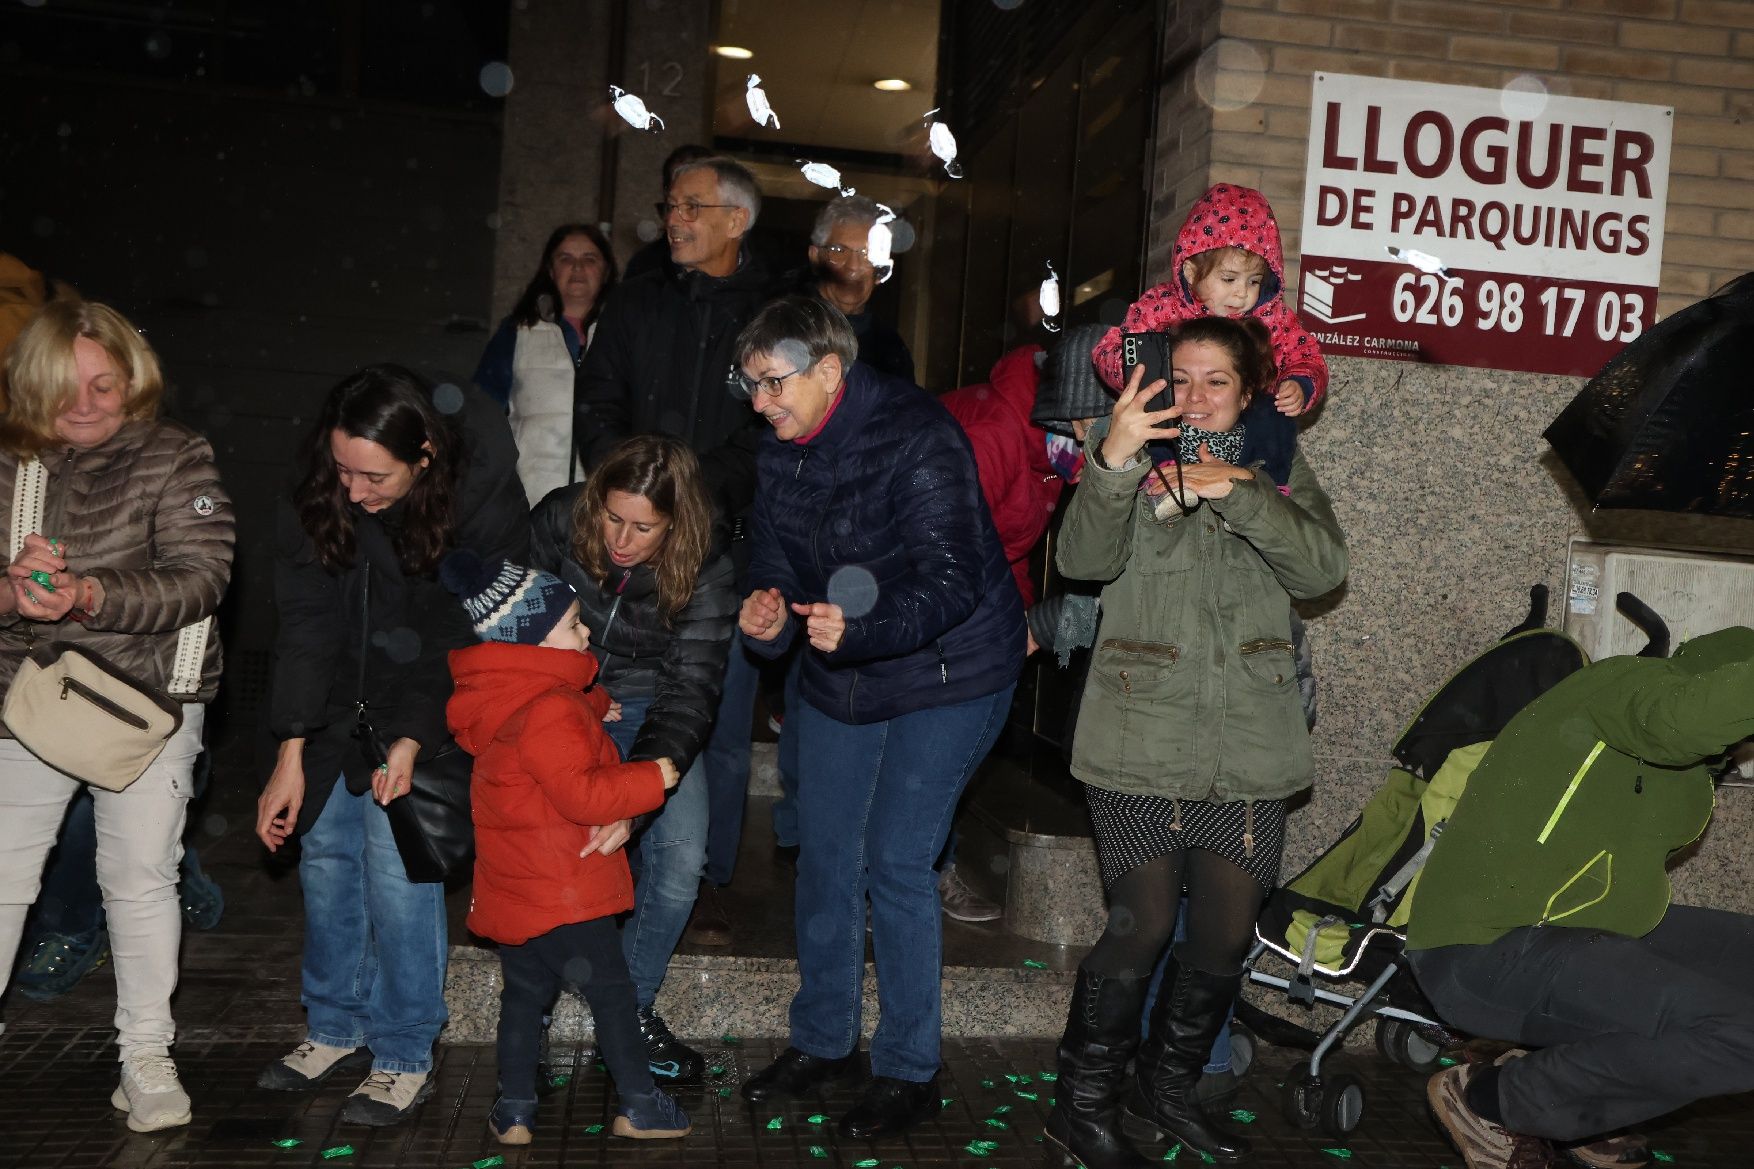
[500,918,654,1101]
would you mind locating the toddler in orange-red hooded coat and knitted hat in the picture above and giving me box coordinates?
[440,551,691,1144]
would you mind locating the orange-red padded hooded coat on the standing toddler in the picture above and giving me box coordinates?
[446,642,663,946]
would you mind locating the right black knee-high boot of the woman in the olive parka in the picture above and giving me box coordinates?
[1126,950,1249,1162]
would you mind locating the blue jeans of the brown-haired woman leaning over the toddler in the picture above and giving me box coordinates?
[603,699,707,1008]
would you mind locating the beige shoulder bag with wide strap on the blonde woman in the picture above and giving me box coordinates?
[0,458,212,792]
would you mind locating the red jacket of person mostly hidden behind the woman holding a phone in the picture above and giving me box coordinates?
[938,346,1065,607]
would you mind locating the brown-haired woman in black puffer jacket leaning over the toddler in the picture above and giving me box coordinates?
[530,435,737,1083]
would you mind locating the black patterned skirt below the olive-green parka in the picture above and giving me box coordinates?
[1084,783,1286,890]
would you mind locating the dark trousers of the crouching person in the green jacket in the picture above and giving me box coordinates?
[1408,906,1754,1141]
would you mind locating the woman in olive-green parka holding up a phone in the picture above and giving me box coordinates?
[1047,316,1347,1169]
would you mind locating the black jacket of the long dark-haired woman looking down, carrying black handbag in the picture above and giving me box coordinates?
[268,382,530,832]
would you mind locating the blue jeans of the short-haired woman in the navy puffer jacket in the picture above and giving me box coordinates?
[786,686,1012,1083]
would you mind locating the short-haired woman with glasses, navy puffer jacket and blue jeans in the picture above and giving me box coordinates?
[737,297,1024,1139]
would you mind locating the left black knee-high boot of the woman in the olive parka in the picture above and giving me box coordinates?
[1047,967,1151,1169]
